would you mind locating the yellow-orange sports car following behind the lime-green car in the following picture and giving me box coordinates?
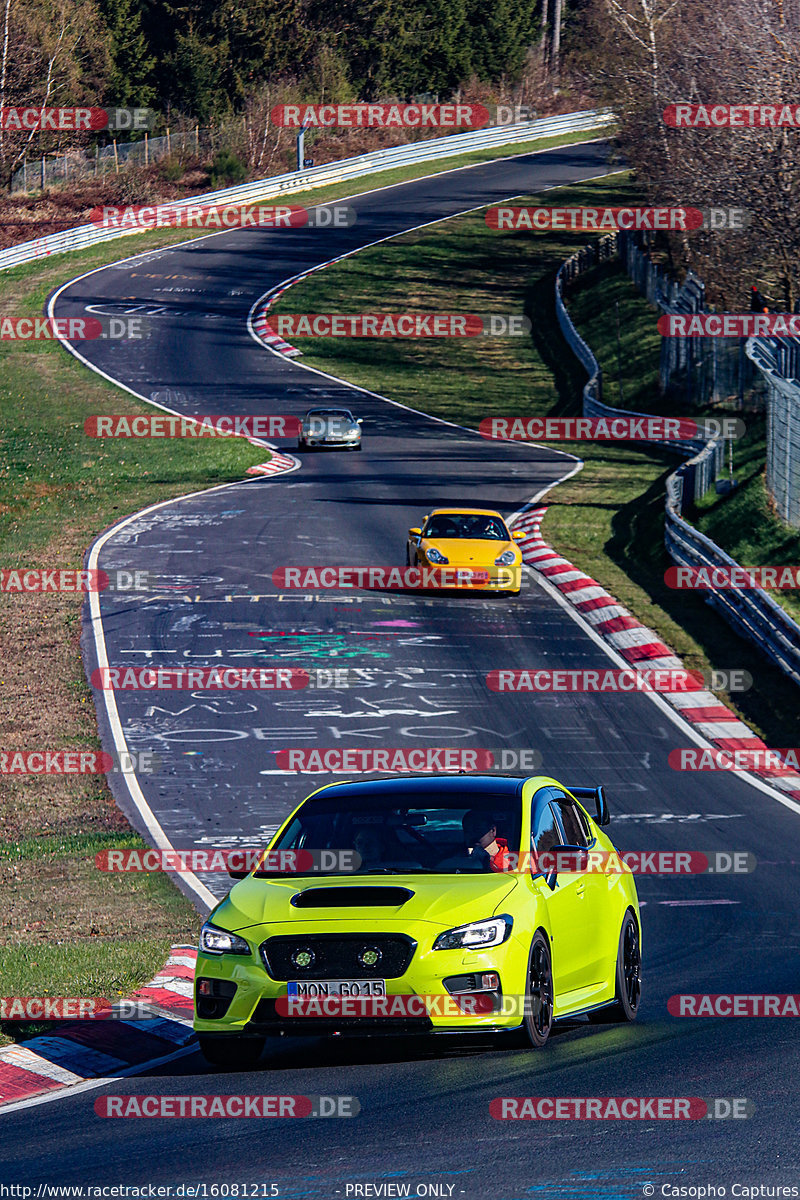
[405,509,524,595]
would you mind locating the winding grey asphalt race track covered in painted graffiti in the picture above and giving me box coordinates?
[6,143,800,1200]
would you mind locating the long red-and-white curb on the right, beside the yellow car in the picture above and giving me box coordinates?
[515,508,800,799]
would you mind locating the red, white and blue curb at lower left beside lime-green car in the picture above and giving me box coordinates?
[0,946,197,1112]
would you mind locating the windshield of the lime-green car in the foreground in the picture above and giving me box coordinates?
[266,792,521,875]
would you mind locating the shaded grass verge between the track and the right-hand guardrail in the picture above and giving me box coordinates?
[267,175,796,745]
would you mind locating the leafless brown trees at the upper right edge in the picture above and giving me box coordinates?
[583,0,800,310]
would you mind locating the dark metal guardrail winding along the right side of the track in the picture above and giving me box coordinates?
[555,236,800,685]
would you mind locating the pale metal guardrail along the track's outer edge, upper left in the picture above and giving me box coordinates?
[0,109,614,270]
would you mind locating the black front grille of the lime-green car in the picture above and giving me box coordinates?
[259,934,416,979]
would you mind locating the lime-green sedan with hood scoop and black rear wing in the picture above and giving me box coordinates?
[194,775,642,1066]
